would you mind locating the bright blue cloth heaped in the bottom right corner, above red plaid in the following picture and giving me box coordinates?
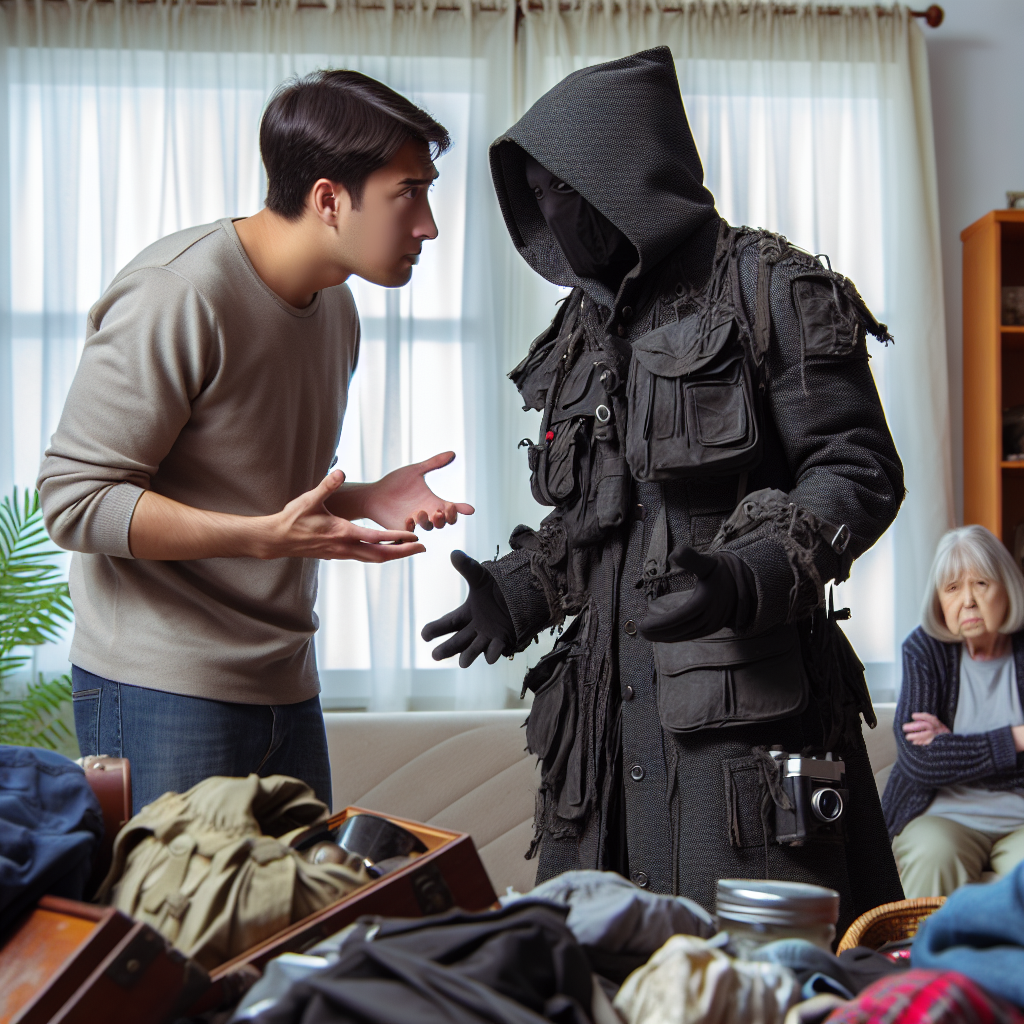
[910,862,1024,1010]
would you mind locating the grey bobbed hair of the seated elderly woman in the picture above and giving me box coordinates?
[921,525,1024,643]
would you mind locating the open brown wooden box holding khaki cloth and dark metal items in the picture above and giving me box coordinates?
[191,807,498,1013]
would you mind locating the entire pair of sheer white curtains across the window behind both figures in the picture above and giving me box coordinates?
[0,0,952,710]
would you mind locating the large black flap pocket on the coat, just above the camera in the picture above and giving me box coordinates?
[653,626,808,733]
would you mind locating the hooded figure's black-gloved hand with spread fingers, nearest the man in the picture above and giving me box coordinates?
[420,551,515,669]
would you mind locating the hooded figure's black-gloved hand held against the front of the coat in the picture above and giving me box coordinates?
[640,548,758,643]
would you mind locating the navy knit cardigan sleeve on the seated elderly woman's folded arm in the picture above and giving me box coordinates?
[893,630,1018,790]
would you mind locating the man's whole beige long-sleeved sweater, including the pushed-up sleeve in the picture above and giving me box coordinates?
[39,220,359,703]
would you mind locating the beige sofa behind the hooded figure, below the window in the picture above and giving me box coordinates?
[324,705,896,893]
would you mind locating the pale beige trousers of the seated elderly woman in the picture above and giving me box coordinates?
[893,814,1024,899]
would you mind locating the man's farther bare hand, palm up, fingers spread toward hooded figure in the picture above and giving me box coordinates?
[328,452,475,530]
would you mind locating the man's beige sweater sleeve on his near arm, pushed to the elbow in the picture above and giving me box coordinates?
[37,267,217,558]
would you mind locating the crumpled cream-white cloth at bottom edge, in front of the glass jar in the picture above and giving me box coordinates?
[614,935,801,1024]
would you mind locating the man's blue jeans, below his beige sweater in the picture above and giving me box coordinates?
[72,666,331,813]
